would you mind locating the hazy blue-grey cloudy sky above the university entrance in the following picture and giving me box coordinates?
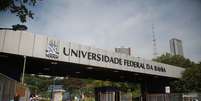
[0,0,201,62]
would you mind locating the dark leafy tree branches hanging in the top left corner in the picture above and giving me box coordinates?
[0,0,39,23]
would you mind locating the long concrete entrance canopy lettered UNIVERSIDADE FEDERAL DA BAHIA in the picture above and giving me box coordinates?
[0,30,184,93]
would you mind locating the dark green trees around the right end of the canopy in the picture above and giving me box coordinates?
[153,53,201,92]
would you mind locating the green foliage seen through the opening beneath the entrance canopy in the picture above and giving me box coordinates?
[25,74,141,98]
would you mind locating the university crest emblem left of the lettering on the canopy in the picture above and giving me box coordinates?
[46,40,59,59]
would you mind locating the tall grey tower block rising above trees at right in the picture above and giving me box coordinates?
[170,38,184,56]
